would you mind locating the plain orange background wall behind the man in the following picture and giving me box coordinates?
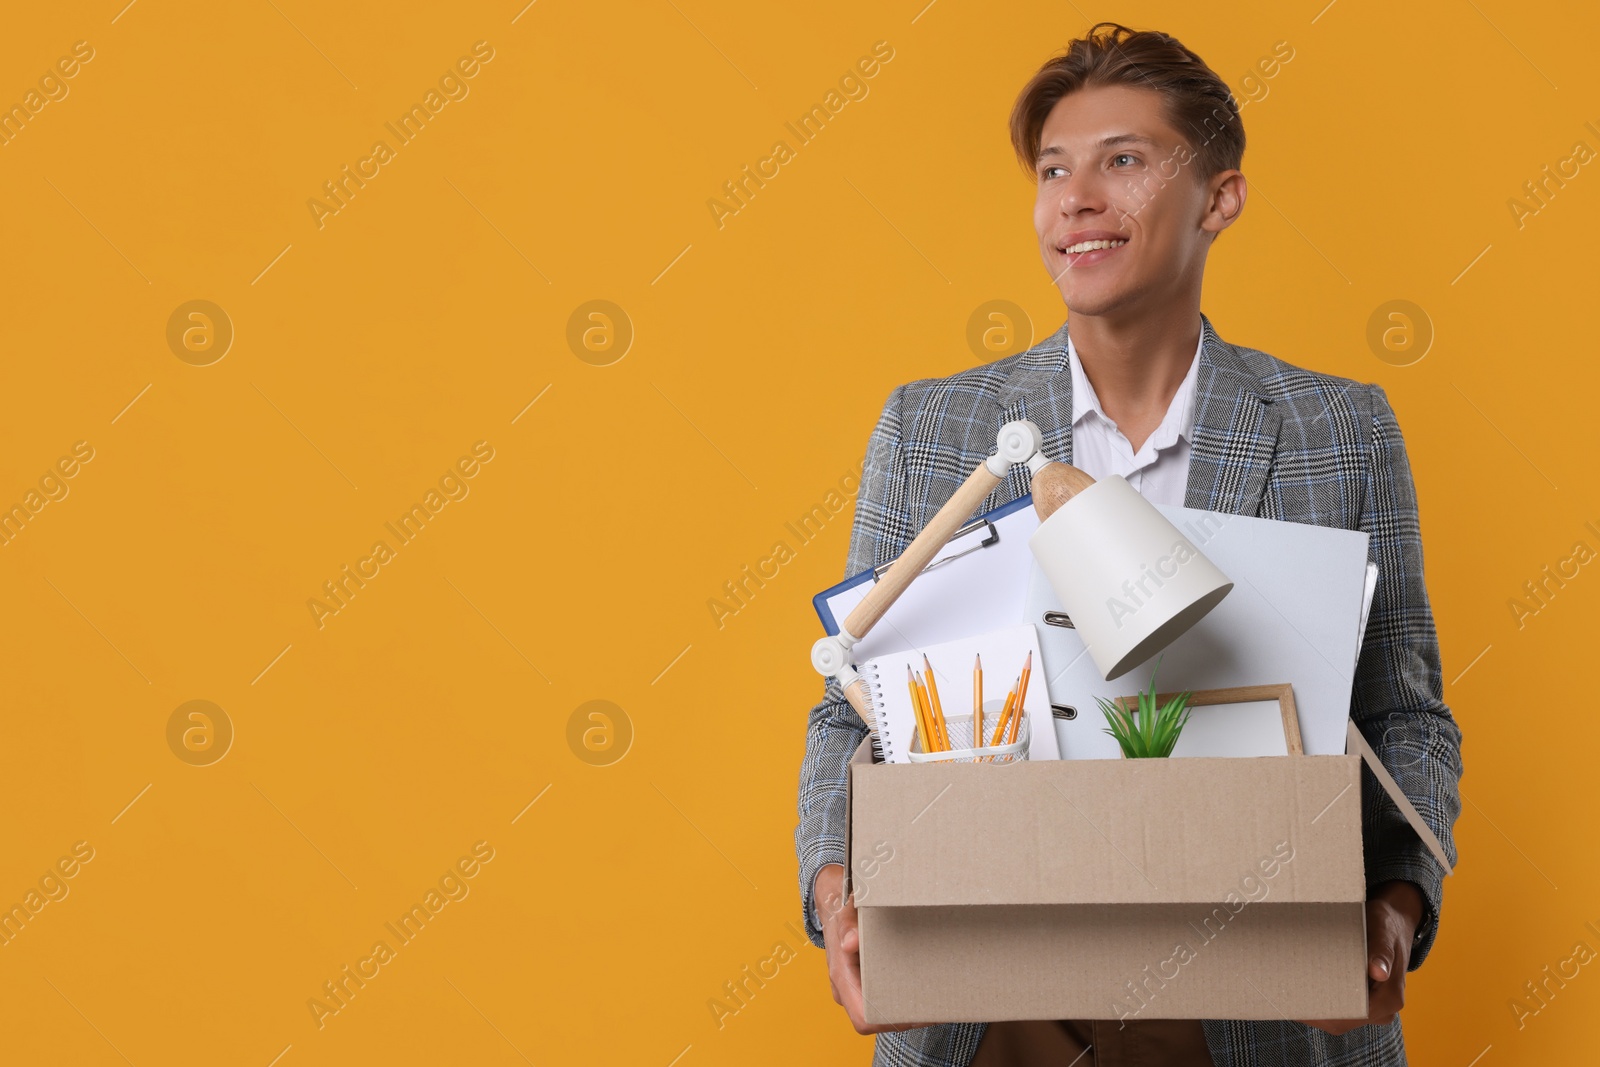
[0,0,1600,1067]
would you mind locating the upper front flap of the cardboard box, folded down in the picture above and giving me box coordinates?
[851,755,1366,907]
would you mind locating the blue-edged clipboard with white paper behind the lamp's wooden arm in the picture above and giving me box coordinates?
[811,494,1038,662]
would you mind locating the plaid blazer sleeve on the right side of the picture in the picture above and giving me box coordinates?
[1350,386,1462,971]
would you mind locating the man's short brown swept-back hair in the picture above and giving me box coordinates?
[1011,22,1245,181]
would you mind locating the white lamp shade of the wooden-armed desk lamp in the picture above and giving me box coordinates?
[1027,475,1234,681]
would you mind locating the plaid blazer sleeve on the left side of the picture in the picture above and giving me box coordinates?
[795,386,906,949]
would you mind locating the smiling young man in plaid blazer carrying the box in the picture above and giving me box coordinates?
[795,22,1461,1067]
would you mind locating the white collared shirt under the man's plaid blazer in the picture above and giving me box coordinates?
[1067,333,1205,506]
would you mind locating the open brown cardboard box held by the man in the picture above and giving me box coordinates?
[846,723,1450,1022]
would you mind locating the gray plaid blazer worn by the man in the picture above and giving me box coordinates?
[795,315,1461,1067]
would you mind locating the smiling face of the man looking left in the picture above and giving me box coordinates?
[1034,86,1238,315]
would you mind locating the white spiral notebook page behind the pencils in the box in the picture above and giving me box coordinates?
[856,622,1061,763]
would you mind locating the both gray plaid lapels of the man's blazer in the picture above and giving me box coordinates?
[986,314,1282,515]
